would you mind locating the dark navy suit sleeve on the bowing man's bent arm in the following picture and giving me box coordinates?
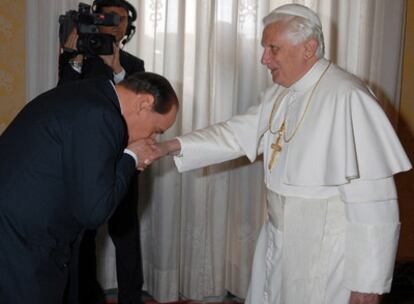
[63,109,135,229]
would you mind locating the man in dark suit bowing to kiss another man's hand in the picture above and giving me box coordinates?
[0,73,178,304]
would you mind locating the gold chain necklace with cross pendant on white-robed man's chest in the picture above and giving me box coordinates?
[268,62,331,171]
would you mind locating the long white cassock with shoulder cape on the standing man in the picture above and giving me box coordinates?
[174,59,411,304]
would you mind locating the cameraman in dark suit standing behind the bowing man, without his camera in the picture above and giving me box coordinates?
[58,0,144,304]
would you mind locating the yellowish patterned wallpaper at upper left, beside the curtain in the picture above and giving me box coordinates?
[0,0,26,134]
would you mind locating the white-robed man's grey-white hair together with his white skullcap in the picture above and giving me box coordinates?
[263,4,325,58]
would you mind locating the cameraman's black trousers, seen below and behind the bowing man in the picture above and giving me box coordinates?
[79,174,143,304]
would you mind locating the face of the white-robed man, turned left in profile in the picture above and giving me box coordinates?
[261,21,308,88]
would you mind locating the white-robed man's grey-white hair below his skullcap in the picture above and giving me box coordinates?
[263,12,325,58]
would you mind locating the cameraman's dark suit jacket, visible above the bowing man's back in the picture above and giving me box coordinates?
[58,50,144,85]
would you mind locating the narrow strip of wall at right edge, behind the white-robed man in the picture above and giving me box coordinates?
[396,0,414,261]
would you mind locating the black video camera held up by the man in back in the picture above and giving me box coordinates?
[59,3,120,57]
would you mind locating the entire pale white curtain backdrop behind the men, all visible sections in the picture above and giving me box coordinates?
[27,0,405,301]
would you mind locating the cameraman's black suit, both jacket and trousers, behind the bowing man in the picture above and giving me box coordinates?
[58,50,144,303]
